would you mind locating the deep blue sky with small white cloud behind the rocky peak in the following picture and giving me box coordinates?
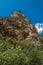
[0,0,43,35]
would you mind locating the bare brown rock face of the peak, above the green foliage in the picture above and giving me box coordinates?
[0,11,38,39]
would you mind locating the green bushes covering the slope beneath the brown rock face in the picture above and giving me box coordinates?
[0,35,43,65]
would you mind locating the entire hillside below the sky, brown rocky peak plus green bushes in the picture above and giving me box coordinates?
[0,11,43,65]
